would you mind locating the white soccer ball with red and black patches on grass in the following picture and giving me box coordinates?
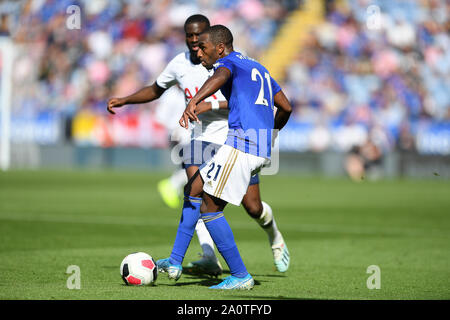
[120,252,158,286]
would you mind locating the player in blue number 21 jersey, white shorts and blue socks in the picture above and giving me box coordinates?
[157,25,292,289]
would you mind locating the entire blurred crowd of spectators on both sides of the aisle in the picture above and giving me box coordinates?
[0,0,450,152]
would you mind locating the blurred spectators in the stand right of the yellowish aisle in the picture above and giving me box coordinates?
[285,0,450,152]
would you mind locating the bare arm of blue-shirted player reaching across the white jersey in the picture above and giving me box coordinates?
[179,67,231,129]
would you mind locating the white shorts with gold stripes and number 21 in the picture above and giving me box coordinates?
[200,145,270,206]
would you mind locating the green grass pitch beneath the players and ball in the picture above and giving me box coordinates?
[0,170,450,300]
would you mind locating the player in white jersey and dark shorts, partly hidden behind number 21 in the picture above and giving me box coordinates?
[107,14,290,276]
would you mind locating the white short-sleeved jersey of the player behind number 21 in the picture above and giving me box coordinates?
[156,51,228,144]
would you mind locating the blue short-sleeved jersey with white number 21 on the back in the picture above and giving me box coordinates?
[214,51,281,158]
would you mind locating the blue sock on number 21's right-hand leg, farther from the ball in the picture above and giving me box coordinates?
[201,212,248,278]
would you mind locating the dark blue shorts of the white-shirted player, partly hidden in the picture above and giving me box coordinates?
[180,140,259,186]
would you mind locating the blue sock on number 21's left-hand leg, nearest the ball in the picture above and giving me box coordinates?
[169,196,202,264]
